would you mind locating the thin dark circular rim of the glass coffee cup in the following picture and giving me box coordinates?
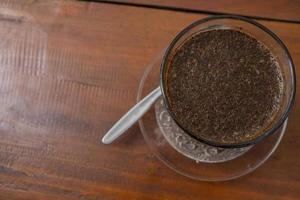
[159,15,296,148]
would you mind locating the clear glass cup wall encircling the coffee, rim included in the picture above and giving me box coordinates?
[160,16,296,148]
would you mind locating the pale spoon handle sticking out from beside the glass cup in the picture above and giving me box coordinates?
[102,87,161,144]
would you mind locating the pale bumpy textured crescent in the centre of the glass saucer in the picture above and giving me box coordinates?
[155,98,252,163]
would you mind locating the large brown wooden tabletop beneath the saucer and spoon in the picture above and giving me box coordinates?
[0,0,300,200]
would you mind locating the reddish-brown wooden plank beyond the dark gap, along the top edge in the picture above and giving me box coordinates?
[106,0,300,22]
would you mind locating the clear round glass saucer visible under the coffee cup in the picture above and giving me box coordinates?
[137,54,287,181]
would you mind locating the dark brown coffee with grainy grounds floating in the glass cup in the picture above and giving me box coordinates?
[164,29,284,145]
